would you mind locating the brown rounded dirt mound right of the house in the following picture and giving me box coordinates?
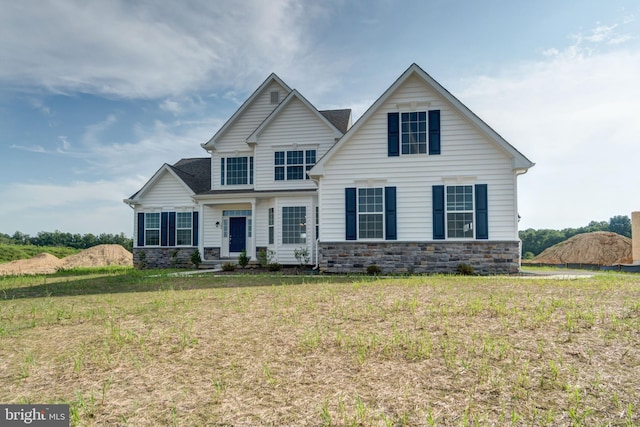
[532,231,632,265]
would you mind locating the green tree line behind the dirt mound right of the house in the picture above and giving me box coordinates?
[520,215,631,259]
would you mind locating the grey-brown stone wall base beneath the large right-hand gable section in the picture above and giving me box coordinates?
[318,241,520,274]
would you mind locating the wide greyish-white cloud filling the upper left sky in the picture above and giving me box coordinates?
[0,0,321,98]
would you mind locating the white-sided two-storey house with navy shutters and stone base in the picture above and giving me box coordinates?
[125,64,533,274]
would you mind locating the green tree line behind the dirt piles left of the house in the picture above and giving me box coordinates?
[0,230,133,251]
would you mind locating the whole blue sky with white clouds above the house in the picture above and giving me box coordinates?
[0,0,640,235]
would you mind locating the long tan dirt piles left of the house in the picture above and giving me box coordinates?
[0,245,133,276]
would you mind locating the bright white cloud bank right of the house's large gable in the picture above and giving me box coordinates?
[457,22,640,228]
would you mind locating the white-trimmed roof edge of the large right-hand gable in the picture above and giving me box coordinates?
[309,63,535,176]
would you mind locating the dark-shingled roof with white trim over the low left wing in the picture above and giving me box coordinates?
[124,157,211,205]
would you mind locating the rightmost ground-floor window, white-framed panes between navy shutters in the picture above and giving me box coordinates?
[446,185,473,239]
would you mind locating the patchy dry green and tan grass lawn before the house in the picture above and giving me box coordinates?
[0,269,640,426]
